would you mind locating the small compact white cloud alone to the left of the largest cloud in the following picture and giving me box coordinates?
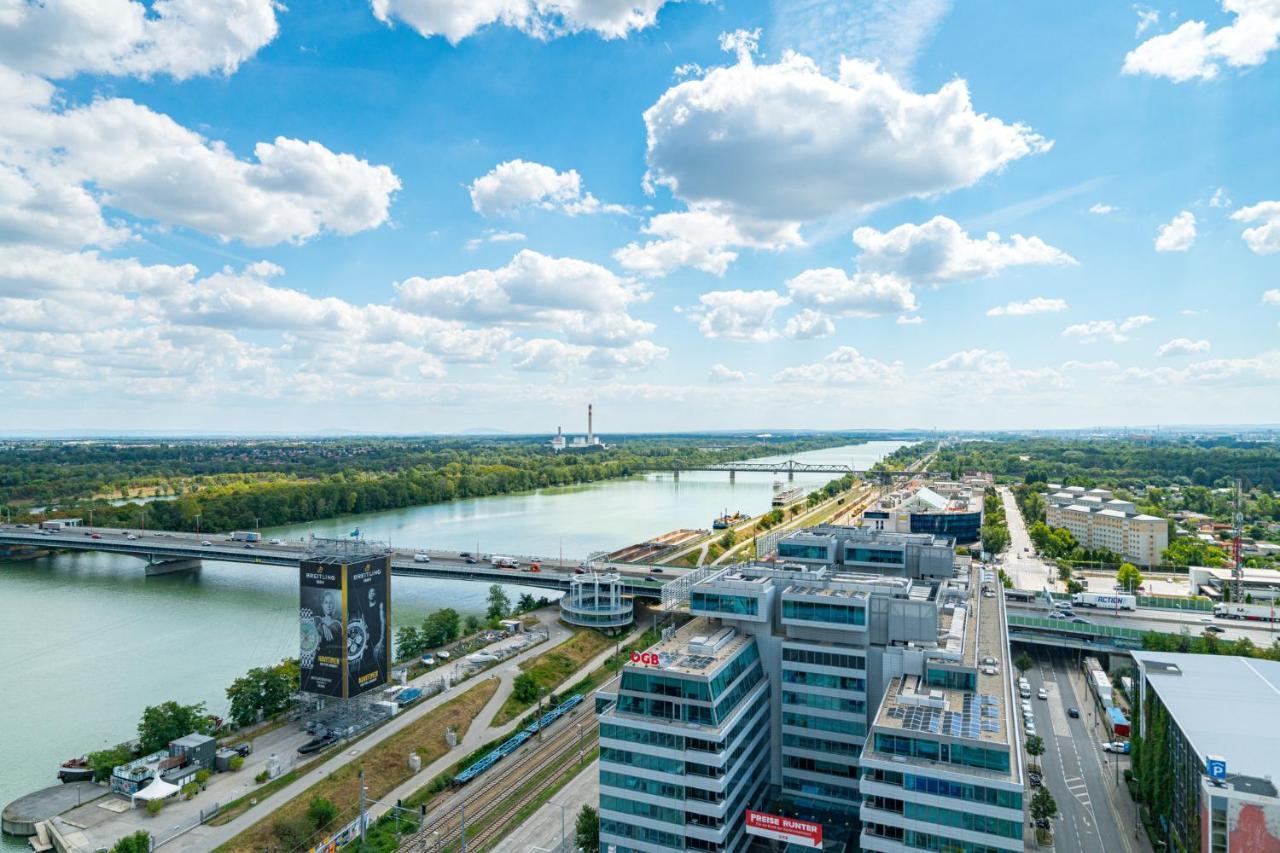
[470,160,626,216]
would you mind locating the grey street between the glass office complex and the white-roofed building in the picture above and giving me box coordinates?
[1027,649,1151,853]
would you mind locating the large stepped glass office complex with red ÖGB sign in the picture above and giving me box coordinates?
[596,529,1025,853]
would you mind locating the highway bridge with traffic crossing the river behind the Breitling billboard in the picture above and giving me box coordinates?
[0,525,682,598]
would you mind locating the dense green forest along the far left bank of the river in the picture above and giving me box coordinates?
[0,433,901,532]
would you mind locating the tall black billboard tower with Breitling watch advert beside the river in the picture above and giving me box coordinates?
[298,557,392,699]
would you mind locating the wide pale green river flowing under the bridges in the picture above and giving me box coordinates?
[0,441,905,824]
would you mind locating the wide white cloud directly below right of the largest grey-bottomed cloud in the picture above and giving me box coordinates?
[854,216,1075,284]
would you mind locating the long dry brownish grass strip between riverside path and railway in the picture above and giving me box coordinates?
[218,679,498,853]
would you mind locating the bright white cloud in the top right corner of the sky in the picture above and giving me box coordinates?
[1124,0,1280,83]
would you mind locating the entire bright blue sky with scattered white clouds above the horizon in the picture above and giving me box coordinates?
[0,0,1280,433]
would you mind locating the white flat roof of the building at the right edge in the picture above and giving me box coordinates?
[1133,652,1280,777]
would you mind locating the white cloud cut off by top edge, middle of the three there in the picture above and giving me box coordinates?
[370,0,680,44]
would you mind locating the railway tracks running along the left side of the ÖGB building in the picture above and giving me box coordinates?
[399,707,598,852]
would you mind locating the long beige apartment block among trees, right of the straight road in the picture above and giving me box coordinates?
[1044,485,1169,566]
